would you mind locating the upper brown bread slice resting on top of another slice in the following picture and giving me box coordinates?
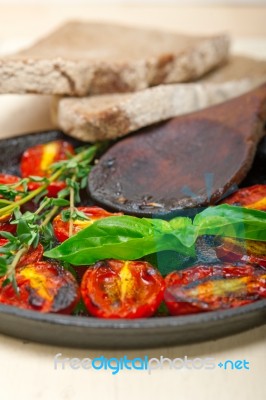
[0,22,229,96]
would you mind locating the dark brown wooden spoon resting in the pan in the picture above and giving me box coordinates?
[89,84,266,216]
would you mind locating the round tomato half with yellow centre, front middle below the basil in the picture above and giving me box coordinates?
[81,260,165,319]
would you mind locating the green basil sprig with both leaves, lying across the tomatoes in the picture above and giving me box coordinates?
[45,204,266,268]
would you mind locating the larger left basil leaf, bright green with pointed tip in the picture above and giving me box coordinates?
[45,216,194,265]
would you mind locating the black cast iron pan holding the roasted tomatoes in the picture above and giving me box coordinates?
[0,131,266,349]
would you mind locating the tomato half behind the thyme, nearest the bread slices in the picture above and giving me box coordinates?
[21,140,74,197]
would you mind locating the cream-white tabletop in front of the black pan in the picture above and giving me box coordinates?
[0,326,266,400]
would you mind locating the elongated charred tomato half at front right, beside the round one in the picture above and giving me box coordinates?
[164,264,266,315]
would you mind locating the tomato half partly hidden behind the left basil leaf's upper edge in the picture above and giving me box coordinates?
[53,207,122,242]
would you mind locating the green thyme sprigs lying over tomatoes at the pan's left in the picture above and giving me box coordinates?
[0,145,100,291]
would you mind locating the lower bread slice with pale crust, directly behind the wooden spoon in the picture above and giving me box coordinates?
[52,57,266,142]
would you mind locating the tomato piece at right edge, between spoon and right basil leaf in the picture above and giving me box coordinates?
[221,185,266,211]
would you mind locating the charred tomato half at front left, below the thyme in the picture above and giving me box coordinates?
[0,262,80,314]
